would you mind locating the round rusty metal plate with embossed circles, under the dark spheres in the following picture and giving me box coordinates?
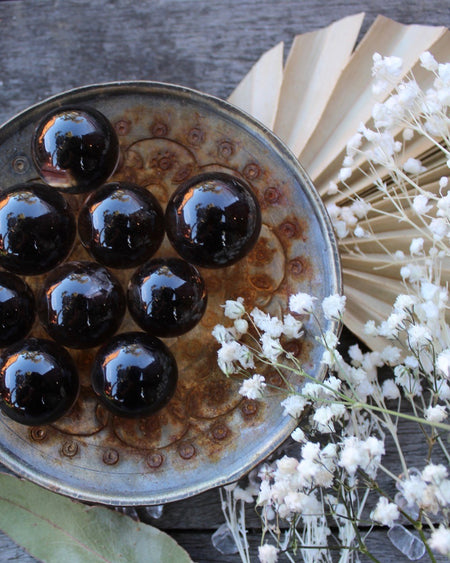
[0,82,340,505]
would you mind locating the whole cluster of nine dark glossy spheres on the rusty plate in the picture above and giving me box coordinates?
[0,107,261,425]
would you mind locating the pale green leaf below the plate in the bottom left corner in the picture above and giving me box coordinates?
[0,474,192,563]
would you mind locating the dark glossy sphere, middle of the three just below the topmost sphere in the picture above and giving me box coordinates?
[78,182,164,268]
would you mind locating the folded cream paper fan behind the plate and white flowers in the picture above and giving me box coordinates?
[229,14,450,349]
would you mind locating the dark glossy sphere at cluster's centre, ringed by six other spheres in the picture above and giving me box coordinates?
[37,262,126,348]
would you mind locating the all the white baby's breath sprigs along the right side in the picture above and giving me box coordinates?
[213,53,450,563]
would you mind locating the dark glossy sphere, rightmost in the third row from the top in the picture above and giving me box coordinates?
[127,258,207,337]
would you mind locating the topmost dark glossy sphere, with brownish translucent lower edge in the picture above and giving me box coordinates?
[32,107,119,193]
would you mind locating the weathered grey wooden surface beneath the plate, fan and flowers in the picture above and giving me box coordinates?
[0,0,450,563]
